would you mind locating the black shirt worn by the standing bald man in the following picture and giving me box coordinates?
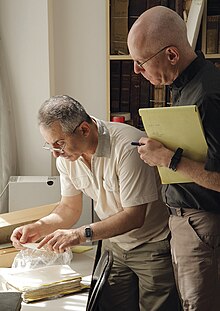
[163,52,220,213]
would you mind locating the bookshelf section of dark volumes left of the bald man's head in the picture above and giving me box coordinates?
[106,0,169,129]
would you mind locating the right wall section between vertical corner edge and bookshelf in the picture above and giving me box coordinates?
[53,0,107,119]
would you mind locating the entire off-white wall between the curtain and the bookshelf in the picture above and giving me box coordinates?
[0,0,107,175]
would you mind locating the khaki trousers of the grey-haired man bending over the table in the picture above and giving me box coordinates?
[100,239,180,311]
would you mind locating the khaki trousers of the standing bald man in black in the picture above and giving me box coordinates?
[169,209,220,311]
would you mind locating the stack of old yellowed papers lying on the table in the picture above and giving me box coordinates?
[3,265,88,302]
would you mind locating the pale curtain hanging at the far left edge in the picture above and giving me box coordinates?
[0,39,17,213]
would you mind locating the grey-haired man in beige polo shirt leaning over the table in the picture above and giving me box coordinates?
[11,96,179,311]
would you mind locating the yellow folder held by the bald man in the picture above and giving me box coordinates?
[139,105,207,184]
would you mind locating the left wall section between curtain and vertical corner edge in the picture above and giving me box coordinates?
[0,0,50,175]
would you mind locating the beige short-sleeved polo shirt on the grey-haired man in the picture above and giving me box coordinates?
[57,119,169,250]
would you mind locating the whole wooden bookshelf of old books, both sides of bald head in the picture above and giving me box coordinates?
[106,0,220,129]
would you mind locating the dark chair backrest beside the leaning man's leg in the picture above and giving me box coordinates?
[86,250,113,311]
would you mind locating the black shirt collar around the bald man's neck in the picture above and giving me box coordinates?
[170,51,205,89]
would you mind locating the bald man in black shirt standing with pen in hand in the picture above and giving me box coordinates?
[128,6,220,311]
